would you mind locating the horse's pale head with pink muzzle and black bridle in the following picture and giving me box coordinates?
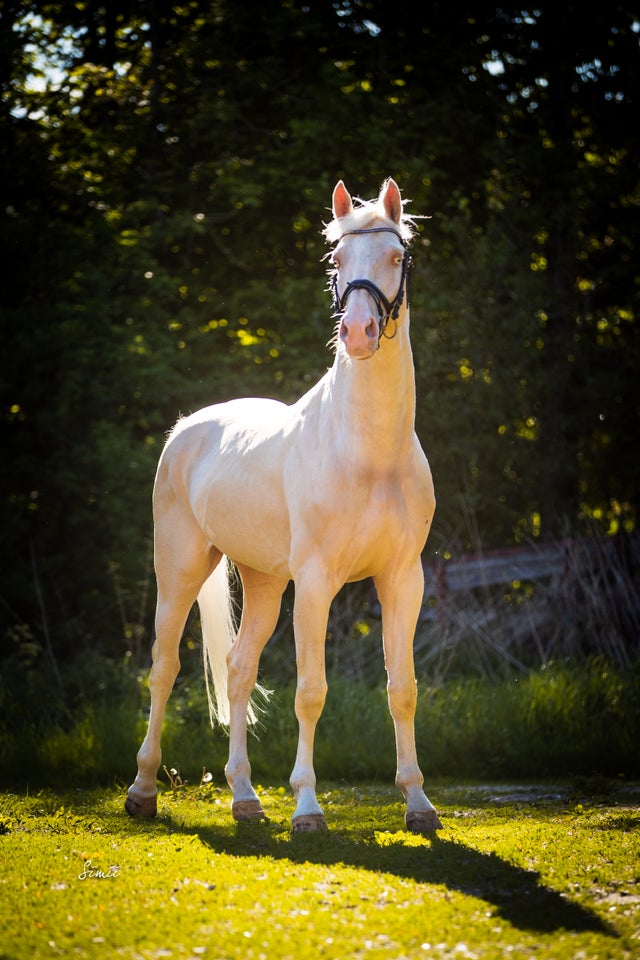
[326,179,411,360]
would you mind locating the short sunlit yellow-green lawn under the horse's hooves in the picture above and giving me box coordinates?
[0,781,640,960]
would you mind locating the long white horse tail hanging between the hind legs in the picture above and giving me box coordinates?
[198,556,270,726]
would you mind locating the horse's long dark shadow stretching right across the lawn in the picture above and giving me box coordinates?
[156,817,617,937]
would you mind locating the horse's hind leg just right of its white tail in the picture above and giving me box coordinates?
[225,565,287,820]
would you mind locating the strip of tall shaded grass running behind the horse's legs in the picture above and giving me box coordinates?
[0,659,640,789]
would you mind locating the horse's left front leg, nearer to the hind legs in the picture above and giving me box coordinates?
[289,568,333,833]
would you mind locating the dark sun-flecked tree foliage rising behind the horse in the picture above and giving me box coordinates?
[0,0,640,662]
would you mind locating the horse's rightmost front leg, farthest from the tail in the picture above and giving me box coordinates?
[376,559,442,833]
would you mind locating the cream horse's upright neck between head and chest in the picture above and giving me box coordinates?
[331,323,416,466]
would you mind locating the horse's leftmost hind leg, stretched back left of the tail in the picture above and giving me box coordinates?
[125,508,221,817]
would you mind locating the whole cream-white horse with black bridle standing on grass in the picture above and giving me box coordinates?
[125,178,441,833]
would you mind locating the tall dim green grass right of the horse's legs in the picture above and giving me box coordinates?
[417,658,640,778]
